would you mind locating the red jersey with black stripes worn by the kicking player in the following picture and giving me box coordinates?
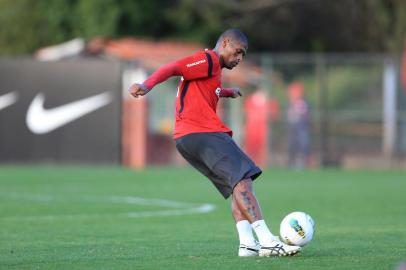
[144,50,232,139]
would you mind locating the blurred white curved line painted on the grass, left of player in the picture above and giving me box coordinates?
[0,193,216,220]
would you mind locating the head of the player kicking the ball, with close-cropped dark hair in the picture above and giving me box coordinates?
[215,28,248,69]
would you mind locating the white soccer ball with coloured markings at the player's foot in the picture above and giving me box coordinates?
[280,212,315,247]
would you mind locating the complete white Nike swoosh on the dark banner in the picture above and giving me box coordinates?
[26,92,113,134]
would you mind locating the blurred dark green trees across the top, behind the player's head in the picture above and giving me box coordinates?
[0,0,406,55]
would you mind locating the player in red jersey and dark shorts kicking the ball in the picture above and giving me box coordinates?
[129,29,300,256]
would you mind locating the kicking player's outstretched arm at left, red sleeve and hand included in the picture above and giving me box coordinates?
[129,52,218,98]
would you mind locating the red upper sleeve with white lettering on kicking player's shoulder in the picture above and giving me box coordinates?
[178,51,216,80]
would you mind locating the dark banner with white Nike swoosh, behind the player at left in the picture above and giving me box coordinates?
[0,59,121,164]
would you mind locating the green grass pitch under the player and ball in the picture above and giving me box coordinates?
[0,166,406,269]
